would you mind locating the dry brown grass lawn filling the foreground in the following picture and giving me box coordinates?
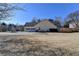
[0,33,79,56]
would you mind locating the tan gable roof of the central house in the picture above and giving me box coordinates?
[34,20,57,28]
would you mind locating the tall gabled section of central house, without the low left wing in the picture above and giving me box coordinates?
[34,20,57,31]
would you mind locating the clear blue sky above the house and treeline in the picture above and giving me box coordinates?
[2,3,79,25]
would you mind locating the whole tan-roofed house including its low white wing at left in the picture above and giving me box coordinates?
[25,20,57,31]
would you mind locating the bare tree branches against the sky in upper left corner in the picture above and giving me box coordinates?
[0,3,21,20]
